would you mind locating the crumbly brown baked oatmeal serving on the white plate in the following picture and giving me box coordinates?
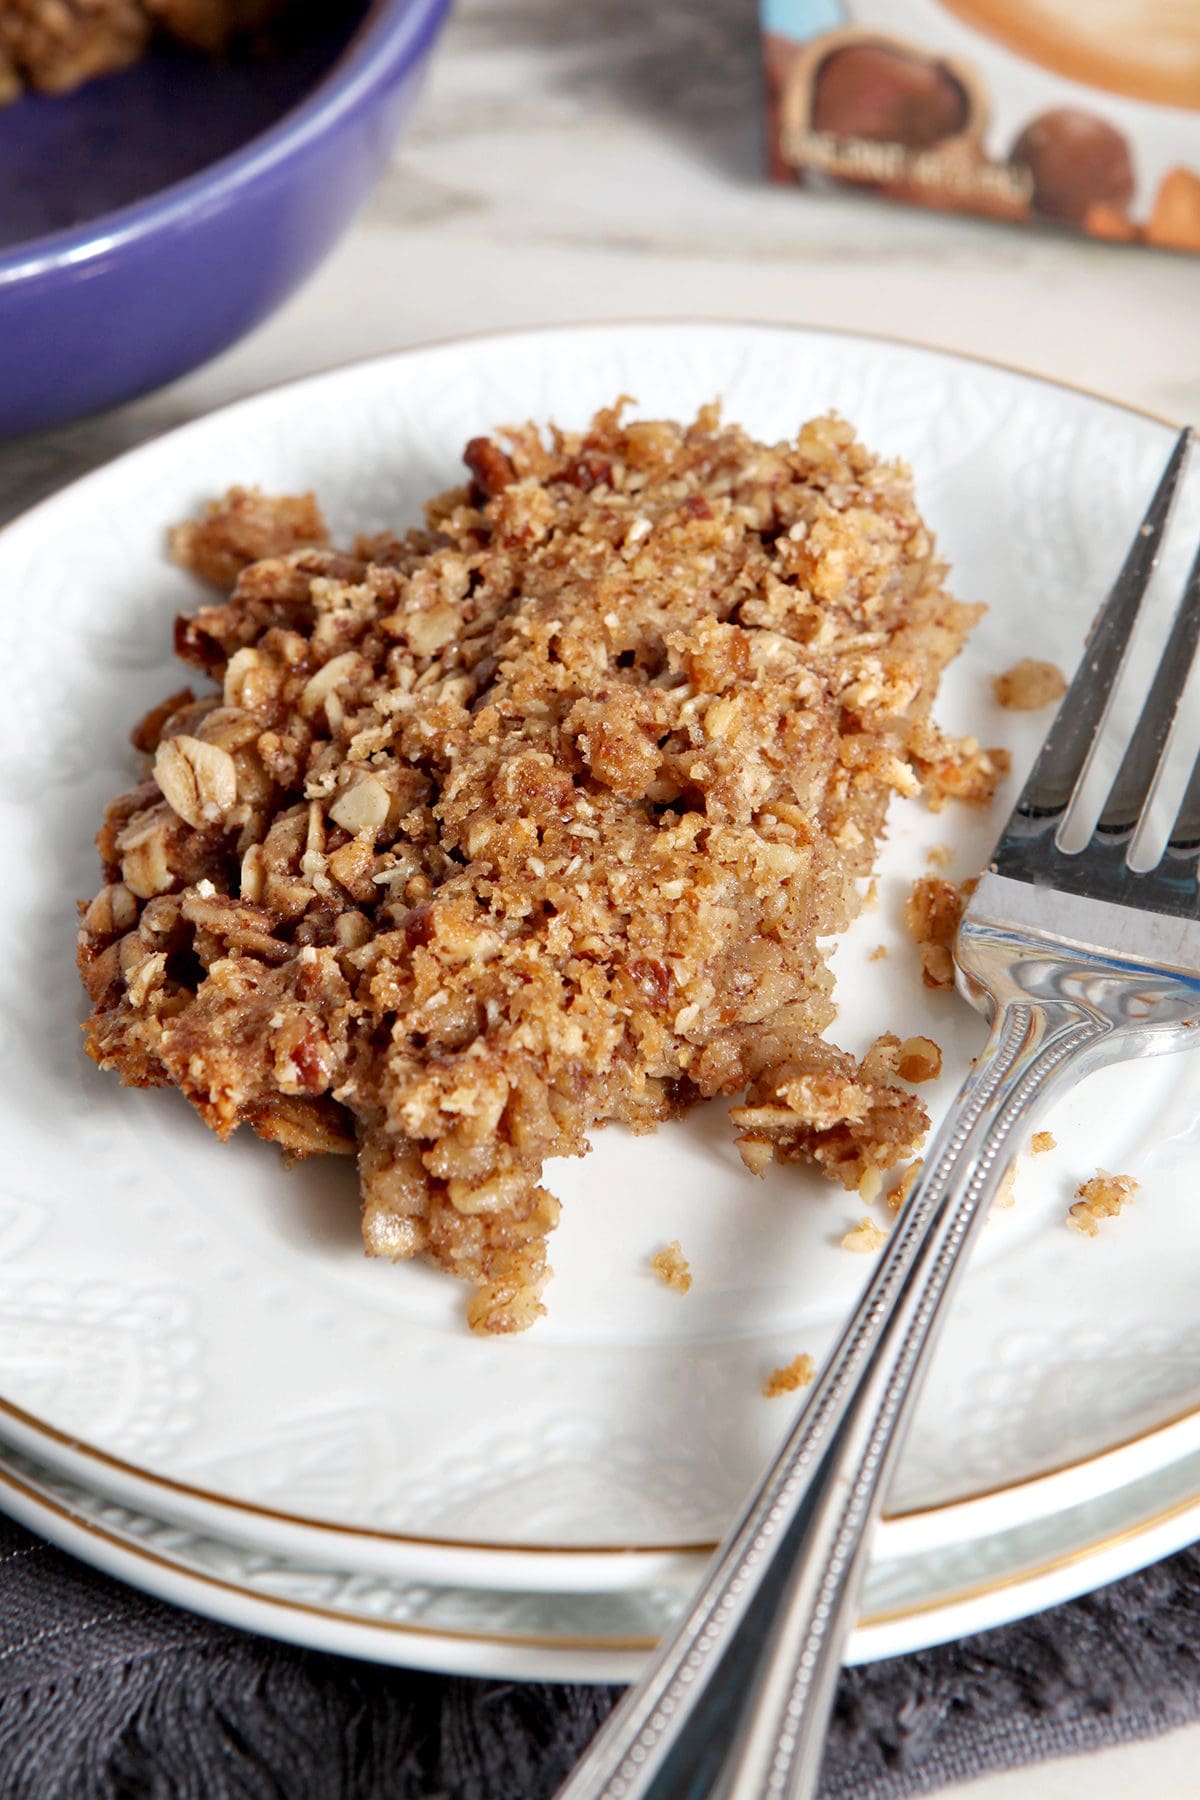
[70,405,999,1332]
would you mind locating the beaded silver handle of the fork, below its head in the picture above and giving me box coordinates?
[560,999,1112,1800]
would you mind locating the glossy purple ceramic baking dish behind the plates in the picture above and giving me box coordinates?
[0,0,450,436]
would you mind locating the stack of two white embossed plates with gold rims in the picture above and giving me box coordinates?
[0,324,1200,1679]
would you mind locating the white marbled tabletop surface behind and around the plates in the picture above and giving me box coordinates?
[0,0,1200,1800]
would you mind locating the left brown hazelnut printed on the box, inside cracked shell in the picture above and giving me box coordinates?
[810,43,970,149]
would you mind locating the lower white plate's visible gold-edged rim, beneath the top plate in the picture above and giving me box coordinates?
[0,1418,1200,1681]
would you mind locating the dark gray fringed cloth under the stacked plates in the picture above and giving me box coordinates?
[0,1517,1200,1800]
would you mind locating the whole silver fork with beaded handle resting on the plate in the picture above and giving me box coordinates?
[560,430,1200,1800]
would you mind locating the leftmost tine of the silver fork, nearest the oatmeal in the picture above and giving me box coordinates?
[1016,427,1193,819]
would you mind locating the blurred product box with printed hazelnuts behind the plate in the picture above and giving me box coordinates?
[761,0,1200,250]
